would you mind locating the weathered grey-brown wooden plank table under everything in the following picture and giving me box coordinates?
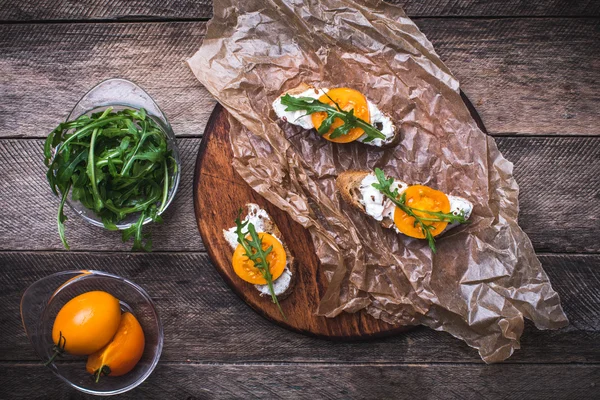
[0,0,600,399]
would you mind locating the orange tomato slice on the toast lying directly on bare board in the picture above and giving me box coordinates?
[231,232,286,285]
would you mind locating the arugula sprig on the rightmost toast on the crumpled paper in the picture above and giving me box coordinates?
[372,168,469,253]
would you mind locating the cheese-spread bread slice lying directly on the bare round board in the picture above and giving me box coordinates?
[223,203,297,300]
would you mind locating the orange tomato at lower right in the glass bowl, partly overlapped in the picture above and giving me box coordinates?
[85,312,146,382]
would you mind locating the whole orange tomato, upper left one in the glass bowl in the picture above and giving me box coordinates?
[52,291,121,356]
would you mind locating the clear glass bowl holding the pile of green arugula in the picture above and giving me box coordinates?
[62,78,181,230]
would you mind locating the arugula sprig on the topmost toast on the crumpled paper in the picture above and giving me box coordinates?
[281,94,385,143]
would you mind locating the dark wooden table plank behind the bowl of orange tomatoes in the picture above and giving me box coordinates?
[0,252,600,364]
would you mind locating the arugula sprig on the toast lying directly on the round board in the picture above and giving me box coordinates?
[235,208,287,320]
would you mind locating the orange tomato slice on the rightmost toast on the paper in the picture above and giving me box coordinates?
[394,185,450,239]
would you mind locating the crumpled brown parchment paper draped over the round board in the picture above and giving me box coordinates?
[188,0,568,362]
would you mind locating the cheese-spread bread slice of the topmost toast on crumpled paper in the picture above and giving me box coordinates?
[273,82,401,148]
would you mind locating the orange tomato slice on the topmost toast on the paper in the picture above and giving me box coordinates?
[310,88,371,143]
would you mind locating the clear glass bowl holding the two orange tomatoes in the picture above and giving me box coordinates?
[21,270,163,396]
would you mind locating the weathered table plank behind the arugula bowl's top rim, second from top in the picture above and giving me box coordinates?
[0,18,600,137]
